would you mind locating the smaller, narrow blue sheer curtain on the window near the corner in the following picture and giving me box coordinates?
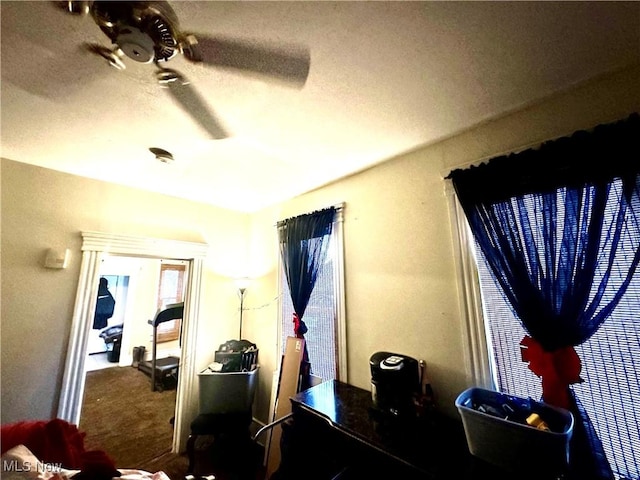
[278,207,336,387]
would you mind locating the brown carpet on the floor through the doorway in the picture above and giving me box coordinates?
[79,367,187,480]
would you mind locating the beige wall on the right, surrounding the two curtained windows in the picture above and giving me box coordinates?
[248,62,640,418]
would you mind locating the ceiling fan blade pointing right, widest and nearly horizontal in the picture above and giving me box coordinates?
[184,35,311,88]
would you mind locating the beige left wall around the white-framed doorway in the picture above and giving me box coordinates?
[1,164,249,423]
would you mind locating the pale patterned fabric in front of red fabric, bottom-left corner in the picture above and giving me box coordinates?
[0,445,79,480]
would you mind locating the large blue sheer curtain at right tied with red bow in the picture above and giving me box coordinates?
[449,114,640,479]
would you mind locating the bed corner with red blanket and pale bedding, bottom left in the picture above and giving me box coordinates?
[0,419,170,480]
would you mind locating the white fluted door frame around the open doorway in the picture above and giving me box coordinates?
[58,232,208,453]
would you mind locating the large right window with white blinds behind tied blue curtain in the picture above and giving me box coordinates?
[460,183,640,480]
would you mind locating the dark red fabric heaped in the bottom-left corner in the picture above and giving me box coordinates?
[0,418,120,479]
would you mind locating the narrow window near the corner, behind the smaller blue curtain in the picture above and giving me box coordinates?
[279,208,347,381]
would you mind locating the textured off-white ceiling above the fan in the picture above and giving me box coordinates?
[0,0,640,211]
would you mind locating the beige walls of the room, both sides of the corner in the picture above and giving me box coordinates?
[1,61,640,432]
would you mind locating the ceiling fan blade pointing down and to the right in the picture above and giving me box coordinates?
[158,69,230,140]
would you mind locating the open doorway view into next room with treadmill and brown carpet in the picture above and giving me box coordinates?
[79,256,189,465]
